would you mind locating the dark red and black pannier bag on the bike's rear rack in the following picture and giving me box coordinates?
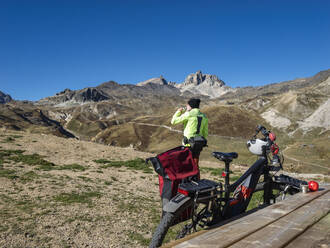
[148,146,199,224]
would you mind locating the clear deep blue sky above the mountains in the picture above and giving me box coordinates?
[0,0,330,100]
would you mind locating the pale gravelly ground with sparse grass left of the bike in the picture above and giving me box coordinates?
[0,132,160,247]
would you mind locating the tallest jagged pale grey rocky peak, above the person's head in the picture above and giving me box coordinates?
[183,71,225,87]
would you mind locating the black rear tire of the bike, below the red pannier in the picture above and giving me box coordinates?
[149,212,175,248]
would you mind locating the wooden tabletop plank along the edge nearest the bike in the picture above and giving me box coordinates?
[167,188,329,248]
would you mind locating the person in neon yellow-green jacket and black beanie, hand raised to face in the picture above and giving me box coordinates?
[171,98,208,165]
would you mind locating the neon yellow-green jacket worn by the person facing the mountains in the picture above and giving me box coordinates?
[171,108,208,139]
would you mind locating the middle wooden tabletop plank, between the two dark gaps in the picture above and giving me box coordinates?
[230,192,330,248]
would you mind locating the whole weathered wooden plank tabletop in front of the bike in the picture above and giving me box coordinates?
[164,186,330,248]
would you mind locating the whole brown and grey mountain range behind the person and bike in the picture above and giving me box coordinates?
[0,69,330,172]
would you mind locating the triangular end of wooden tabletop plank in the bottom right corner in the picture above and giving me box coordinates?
[286,214,330,248]
